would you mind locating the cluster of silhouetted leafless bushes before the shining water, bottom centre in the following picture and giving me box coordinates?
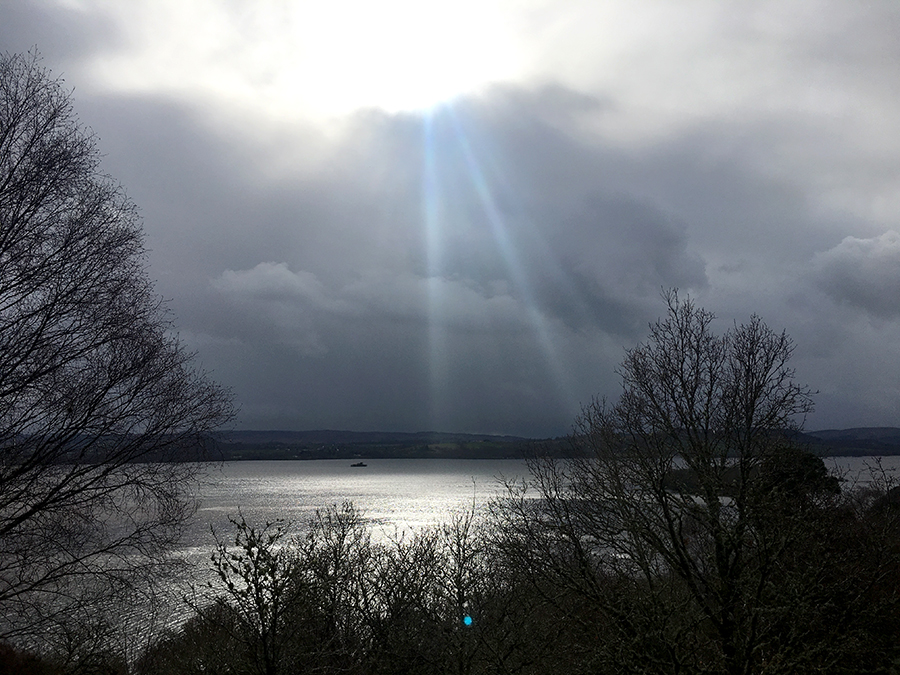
[157,503,567,675]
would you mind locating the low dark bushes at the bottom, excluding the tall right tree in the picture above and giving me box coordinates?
[118,476,900,675]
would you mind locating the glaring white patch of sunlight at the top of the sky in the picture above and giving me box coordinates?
[84,0,516,118]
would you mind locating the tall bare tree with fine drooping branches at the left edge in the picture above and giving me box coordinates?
[0,54,232,636]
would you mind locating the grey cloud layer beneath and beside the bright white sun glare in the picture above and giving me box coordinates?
[0,3,900,435]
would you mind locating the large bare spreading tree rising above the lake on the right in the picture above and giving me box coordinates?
[492,291,834,673]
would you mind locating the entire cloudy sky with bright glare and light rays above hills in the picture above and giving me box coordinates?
[0,0,900,437]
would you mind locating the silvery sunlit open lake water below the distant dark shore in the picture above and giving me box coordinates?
[185,457,900,556]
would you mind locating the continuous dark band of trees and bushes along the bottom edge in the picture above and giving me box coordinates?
[7,448,900,675]
